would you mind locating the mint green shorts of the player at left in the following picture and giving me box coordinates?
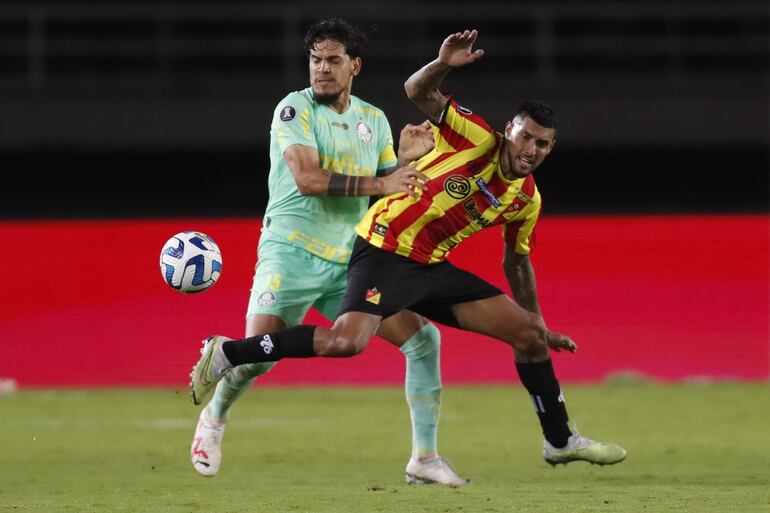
[246,237,348,326]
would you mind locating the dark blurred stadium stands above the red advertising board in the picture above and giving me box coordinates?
[0,0,770,218]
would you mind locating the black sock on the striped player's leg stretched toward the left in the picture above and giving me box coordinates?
[222,324,315,366]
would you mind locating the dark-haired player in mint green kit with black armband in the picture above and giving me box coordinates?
[190,18,467,485]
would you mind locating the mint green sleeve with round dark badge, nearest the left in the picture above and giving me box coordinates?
[270,92,318,153]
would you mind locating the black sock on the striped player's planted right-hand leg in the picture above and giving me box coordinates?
[516,360,572,448]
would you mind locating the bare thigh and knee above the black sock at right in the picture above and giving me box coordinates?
[452,294,548,361]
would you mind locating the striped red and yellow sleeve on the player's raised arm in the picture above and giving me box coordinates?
[433,97,495,153]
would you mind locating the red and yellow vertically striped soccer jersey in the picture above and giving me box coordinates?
[356,99,540,263]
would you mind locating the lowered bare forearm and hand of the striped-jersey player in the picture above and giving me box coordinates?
[503,246,577,353]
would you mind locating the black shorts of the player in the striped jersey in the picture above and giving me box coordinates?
[337,237,503,327]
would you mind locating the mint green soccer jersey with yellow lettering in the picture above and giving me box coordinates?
[262,87,396,262]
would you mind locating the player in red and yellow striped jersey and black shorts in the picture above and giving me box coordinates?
[191,30,626,465]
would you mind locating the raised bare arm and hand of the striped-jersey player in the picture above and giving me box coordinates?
[404,30,484,123]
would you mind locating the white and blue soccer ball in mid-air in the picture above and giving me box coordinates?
[160,232,222,294]
